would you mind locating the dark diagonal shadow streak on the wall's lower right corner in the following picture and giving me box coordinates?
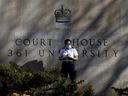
[97,56,128,96]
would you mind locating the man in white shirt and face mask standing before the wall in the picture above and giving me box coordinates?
[59,39,78,81]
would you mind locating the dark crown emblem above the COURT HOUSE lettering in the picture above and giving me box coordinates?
[54,5,71,23]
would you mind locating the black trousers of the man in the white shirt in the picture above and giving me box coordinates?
[61,61,76,81]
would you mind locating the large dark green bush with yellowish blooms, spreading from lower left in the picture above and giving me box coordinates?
[0,62,94,96]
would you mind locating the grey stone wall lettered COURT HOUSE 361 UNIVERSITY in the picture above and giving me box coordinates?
[0,0,128,96]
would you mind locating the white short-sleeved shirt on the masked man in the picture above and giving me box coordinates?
[59,48,78,58]
